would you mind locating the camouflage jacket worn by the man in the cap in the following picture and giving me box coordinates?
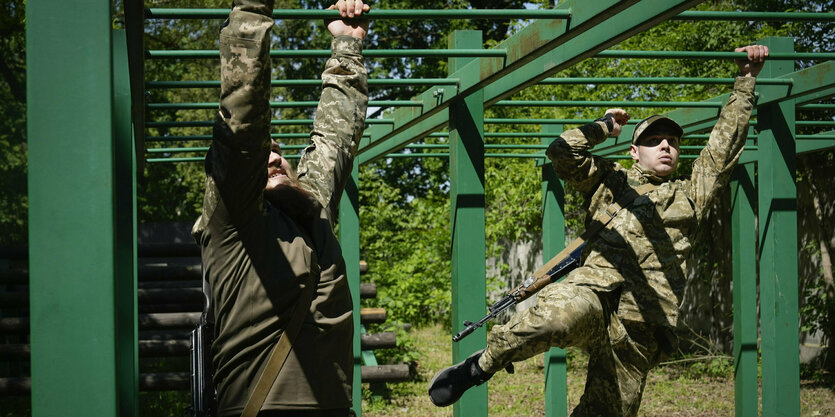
[547,77,755,327]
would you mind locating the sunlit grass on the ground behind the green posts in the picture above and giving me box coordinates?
[362,326,835,417]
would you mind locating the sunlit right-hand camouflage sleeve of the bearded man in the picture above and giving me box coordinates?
[298,36,368,223]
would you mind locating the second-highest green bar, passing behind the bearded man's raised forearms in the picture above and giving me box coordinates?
[145,49,507,59]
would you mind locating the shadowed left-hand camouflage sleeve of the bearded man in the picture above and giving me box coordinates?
[200,0,274,229]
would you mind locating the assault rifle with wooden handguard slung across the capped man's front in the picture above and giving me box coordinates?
[452,243,586,342]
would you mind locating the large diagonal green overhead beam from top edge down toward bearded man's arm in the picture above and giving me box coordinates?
[360,0,701,163]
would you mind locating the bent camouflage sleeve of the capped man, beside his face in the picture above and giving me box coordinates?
[545,121,613,194]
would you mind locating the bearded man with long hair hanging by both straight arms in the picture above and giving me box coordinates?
[193,0,368,417]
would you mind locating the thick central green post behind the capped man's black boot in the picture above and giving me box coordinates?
[449,30,487,417]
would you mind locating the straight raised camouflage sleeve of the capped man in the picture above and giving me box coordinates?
[688,77,756,220]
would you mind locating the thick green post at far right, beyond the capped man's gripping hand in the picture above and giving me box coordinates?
[757,38,800,417]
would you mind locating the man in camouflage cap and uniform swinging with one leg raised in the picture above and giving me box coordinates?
[429,45,768,417]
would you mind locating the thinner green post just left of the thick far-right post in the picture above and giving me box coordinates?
[731,163,759,417]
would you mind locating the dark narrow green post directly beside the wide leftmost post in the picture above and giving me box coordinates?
[113,30,139,416]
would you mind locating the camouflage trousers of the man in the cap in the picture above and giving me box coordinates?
[478,283,661,417]
